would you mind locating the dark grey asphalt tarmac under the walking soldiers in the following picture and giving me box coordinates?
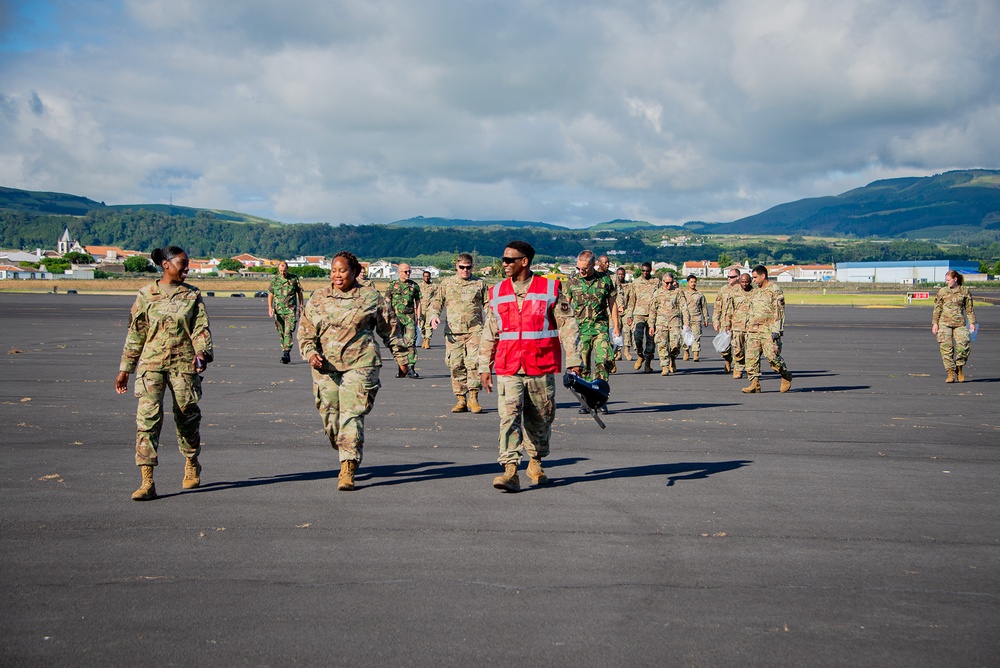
[0,294,1000,666]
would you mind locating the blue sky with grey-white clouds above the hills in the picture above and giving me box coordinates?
[0,0,1000,227]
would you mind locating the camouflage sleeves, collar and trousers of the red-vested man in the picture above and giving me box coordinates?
[479,276,583,465]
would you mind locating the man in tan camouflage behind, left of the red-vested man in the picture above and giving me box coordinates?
[427,253,489,413]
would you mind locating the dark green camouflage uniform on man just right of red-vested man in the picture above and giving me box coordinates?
[564,271,617,380]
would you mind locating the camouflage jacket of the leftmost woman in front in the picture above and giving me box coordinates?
[118,282,213,373]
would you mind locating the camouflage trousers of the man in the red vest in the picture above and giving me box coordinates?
[497,374,556,465]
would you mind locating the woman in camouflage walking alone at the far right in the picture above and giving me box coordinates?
[931,269,976,383]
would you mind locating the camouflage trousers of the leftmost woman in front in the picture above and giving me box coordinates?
[135,371,201,466]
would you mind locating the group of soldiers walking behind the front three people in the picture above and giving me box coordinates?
[269,250,792,413]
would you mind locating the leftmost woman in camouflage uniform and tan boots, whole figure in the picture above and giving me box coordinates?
[115,246,213,501]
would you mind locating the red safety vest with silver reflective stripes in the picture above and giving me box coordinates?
[490,275,562,376]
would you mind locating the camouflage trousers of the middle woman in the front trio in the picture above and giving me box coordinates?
[312,366,382,464]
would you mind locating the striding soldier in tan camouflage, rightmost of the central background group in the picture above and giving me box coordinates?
[743,264,792,394]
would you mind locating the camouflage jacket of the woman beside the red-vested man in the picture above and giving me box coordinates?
[298,285,407,372]
